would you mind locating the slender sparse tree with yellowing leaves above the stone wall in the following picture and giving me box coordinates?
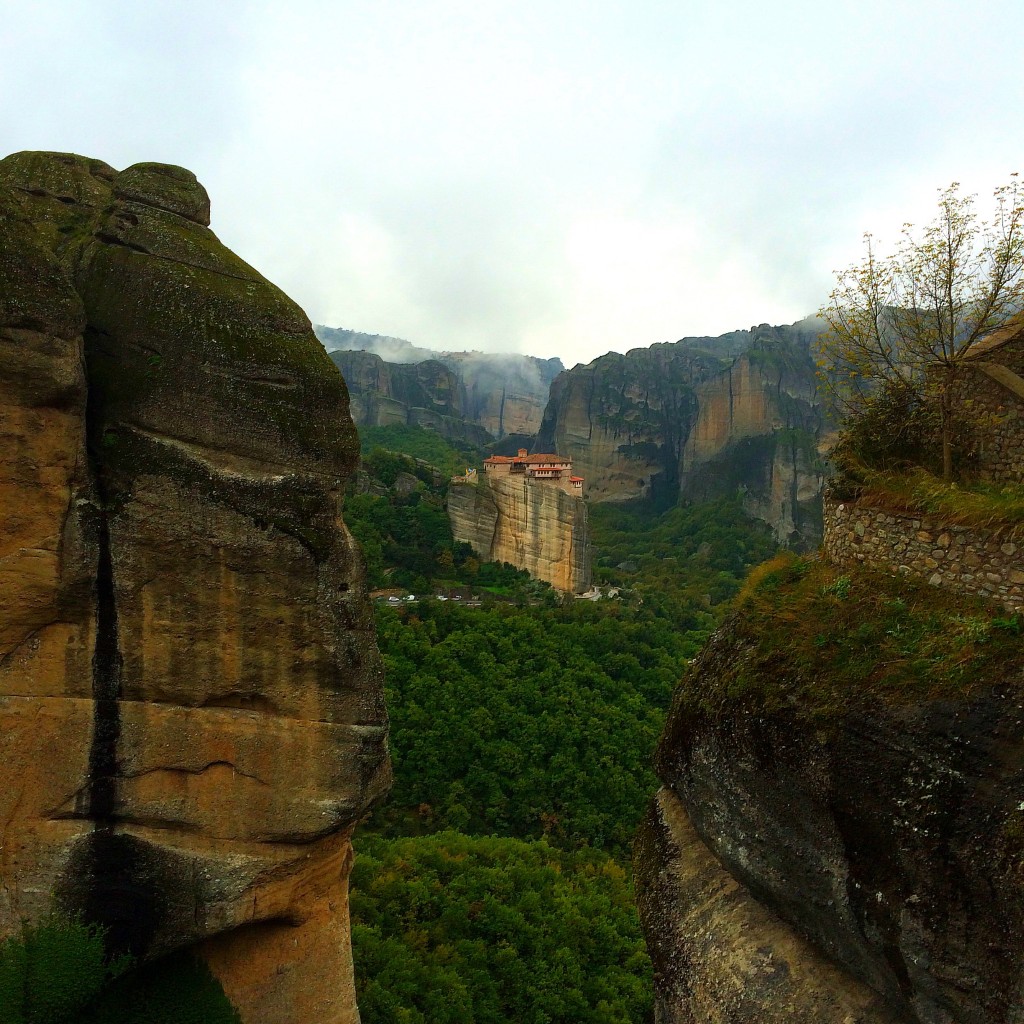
[819,174,1024,482]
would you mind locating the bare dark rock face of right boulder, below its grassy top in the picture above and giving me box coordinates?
[636,611,1024,1024]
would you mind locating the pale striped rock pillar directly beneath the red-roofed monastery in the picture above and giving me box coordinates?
[447,476,591,594]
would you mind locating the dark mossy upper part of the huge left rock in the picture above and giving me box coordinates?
[0,153,358,486]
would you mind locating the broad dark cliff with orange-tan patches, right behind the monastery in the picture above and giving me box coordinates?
[536,322,823,547]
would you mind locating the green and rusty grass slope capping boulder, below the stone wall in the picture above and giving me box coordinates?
[678,554,1024,720]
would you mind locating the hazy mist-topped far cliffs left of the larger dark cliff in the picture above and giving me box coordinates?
[316,327,562,444]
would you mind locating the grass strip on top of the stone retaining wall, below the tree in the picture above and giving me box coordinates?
[843,469,1024,538]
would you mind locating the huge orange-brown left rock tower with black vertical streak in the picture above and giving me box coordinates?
[0,154,389,1024]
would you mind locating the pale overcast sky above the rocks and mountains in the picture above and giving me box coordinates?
[0,0,1024,366]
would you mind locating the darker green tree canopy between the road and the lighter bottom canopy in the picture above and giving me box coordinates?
[368,602,703,856]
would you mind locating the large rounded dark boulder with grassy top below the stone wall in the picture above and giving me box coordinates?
[635,560,1024,1024]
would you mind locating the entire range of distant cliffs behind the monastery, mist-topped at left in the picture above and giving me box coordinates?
[316,319,825,548]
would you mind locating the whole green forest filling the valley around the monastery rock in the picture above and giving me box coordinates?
[345,428,775,1024]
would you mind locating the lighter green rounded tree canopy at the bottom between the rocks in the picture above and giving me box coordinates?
[351,831,651,1024]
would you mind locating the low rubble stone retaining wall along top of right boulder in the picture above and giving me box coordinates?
[824,499,1024,611]
